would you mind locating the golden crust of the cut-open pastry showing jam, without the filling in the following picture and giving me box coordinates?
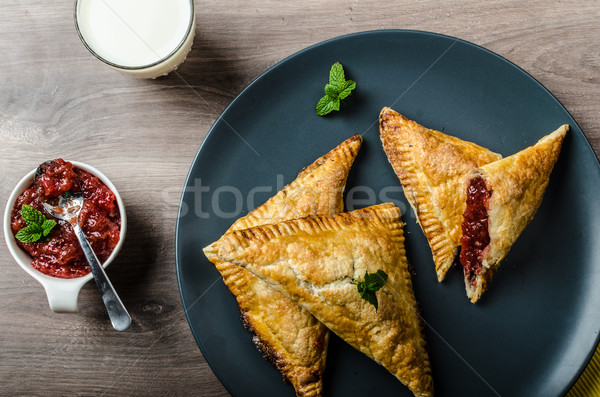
[461,125,569,303]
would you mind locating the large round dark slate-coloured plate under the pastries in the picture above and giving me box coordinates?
[176,31,600,397]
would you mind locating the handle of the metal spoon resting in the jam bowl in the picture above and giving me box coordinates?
[72,222,131,331]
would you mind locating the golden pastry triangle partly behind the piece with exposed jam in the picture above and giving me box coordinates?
[379,108,502,281]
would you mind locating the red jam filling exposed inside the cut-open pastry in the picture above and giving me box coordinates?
[460,177,492,282]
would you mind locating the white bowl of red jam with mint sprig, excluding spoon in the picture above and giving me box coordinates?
[4,159,127,312]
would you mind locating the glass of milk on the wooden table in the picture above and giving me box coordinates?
[75,0,196,78]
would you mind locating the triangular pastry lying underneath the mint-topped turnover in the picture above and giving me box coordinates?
[204,135,362,396]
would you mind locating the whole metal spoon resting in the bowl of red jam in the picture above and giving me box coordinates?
[42,194,131,331]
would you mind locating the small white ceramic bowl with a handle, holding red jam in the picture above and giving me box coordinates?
[4,160,127,312]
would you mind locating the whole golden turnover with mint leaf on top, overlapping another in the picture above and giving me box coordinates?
[205,203,433,396]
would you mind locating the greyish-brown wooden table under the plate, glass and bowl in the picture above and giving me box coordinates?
[0,0,600,396]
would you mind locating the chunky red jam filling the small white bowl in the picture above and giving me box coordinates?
[11,159,121,278]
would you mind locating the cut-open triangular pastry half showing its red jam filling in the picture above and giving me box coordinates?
[460,125,569,303]
